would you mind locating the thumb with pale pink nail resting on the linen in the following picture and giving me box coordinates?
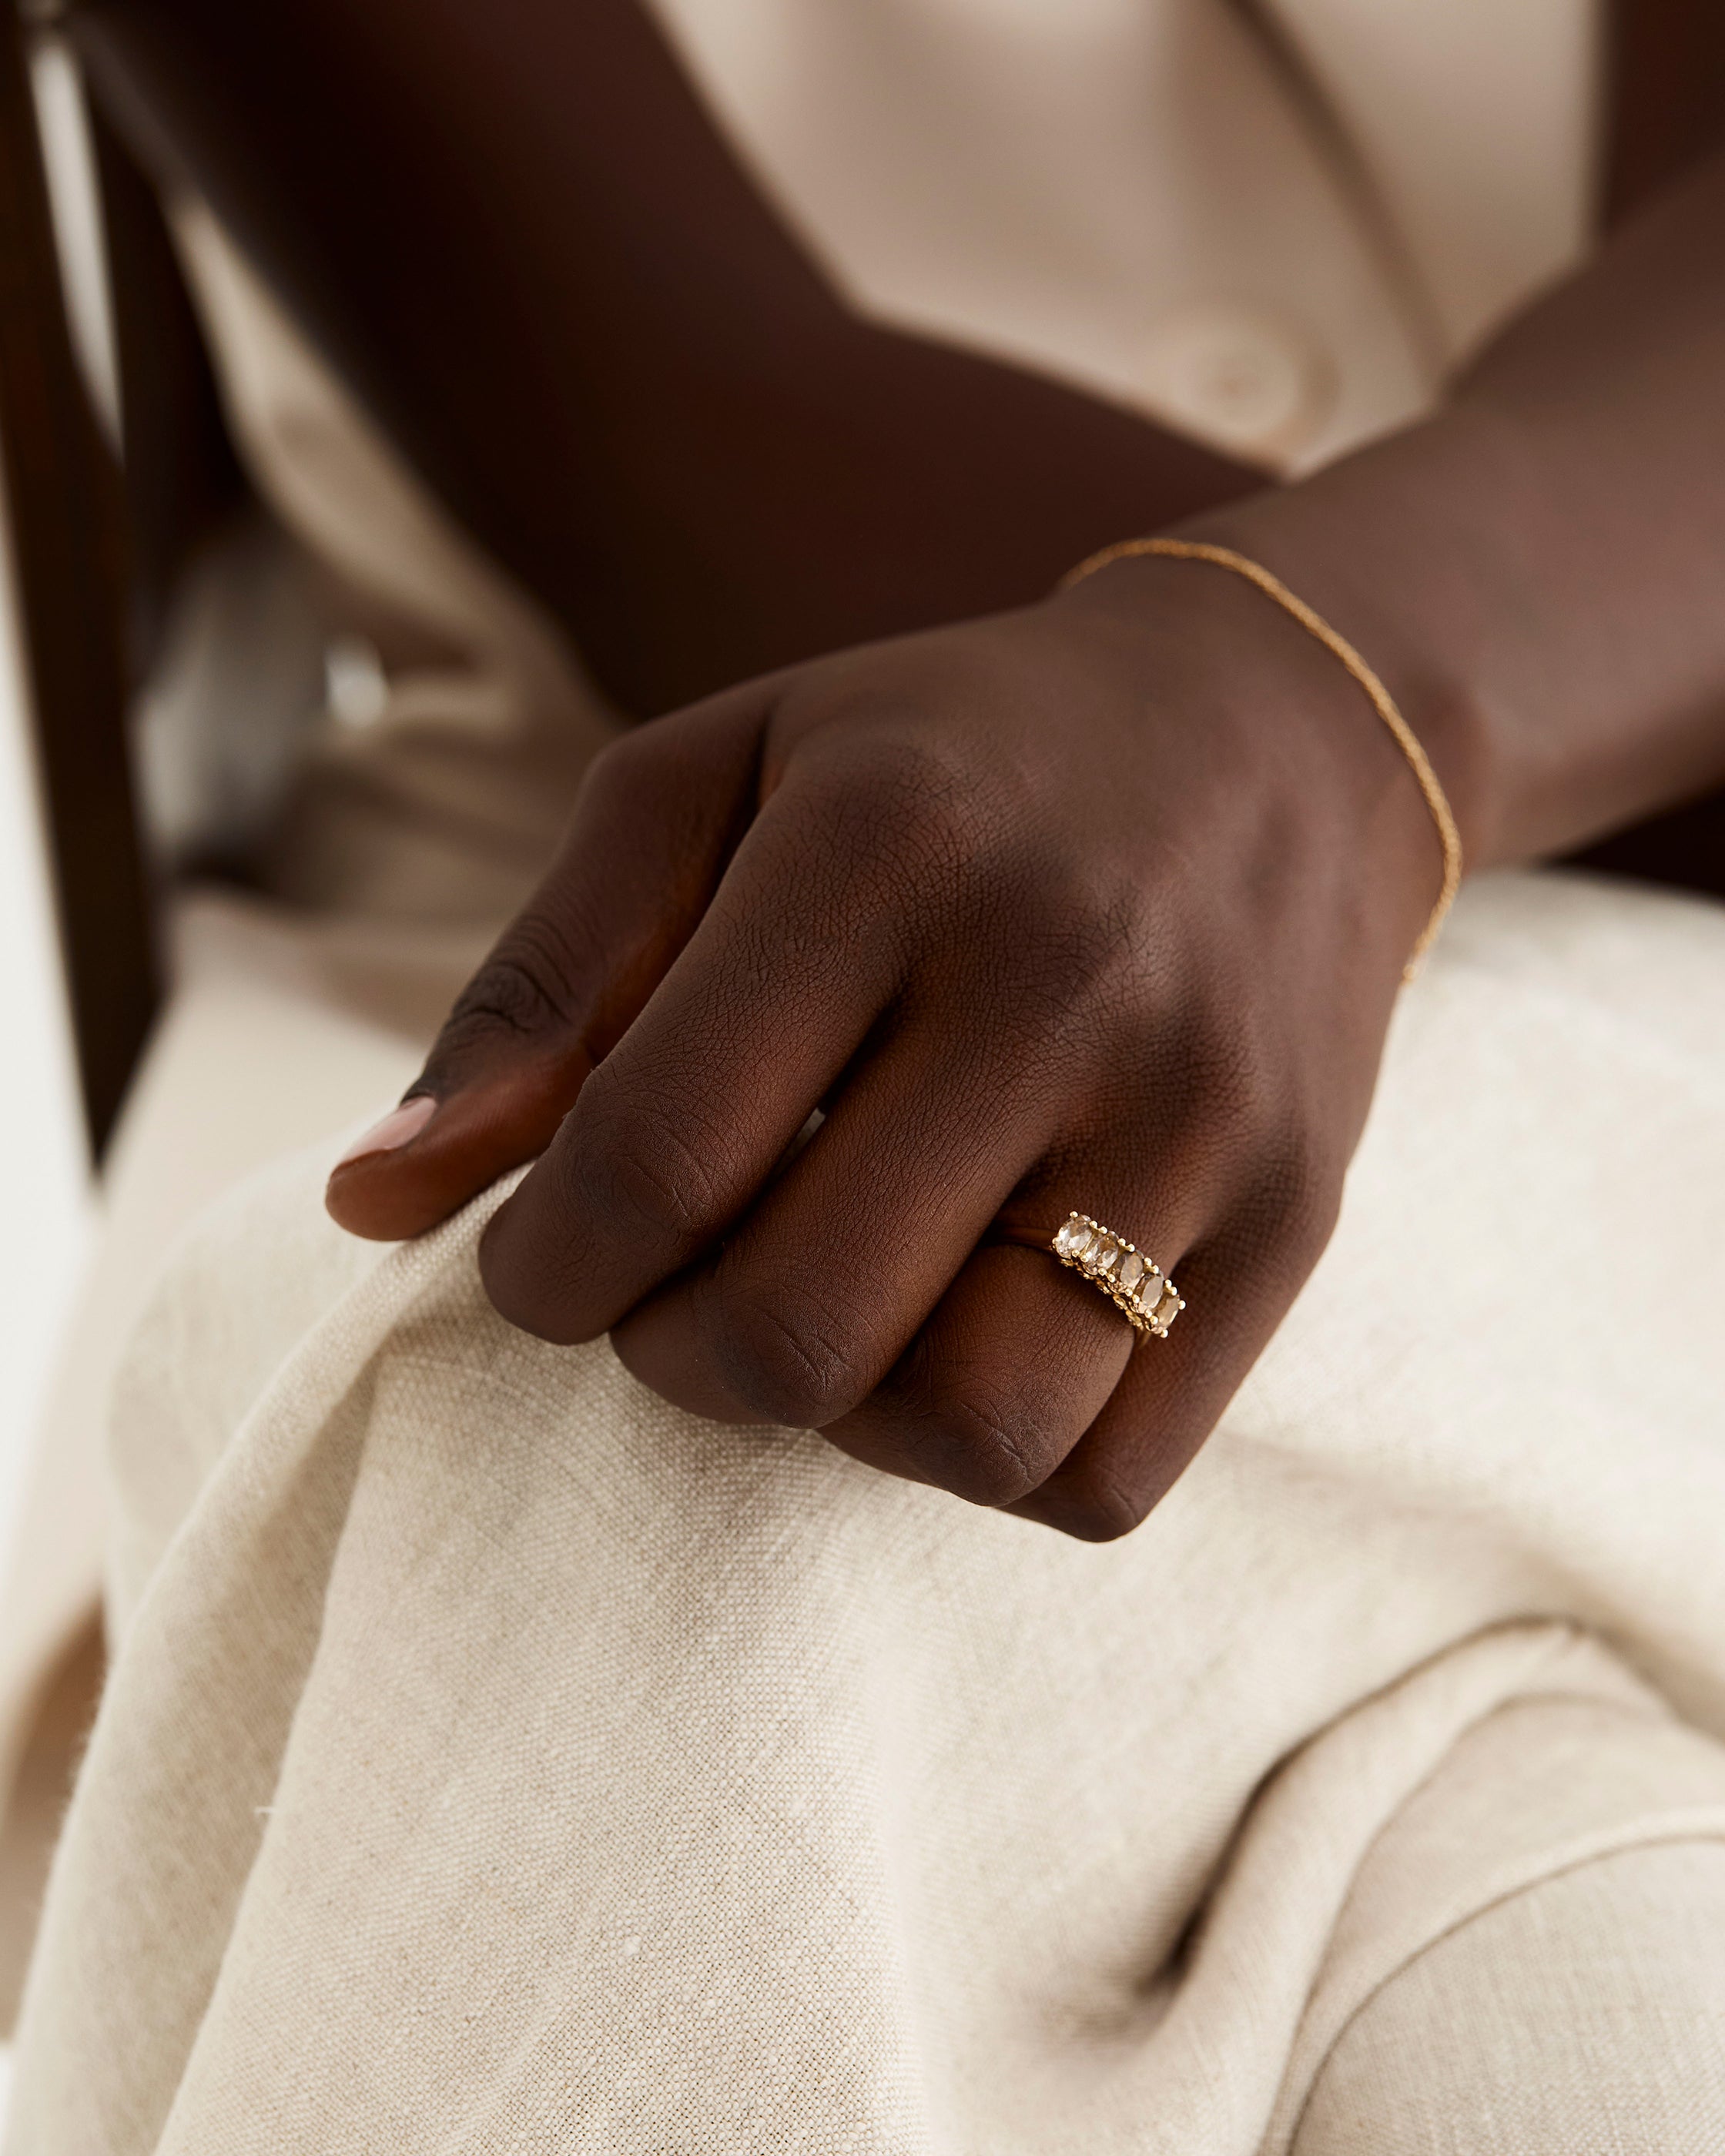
[326,684,768,1242]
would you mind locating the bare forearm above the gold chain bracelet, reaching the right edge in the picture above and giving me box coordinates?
[1194,162,1725,867]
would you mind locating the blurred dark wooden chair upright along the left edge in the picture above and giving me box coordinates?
[0,0,157,1158]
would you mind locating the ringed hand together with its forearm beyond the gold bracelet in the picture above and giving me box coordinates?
[330,152,1725,1539]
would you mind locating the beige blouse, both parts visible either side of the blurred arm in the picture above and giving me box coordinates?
[162,0,1598,921]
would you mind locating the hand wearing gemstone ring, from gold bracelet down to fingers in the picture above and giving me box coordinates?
[330,561,1440,1539]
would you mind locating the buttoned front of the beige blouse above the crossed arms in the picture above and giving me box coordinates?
[638,0,1600,468]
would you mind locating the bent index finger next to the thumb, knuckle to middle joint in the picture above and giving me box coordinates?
[481,742,936,1341]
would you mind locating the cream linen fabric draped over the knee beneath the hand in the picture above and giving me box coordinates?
[6,878,1725,2156]
